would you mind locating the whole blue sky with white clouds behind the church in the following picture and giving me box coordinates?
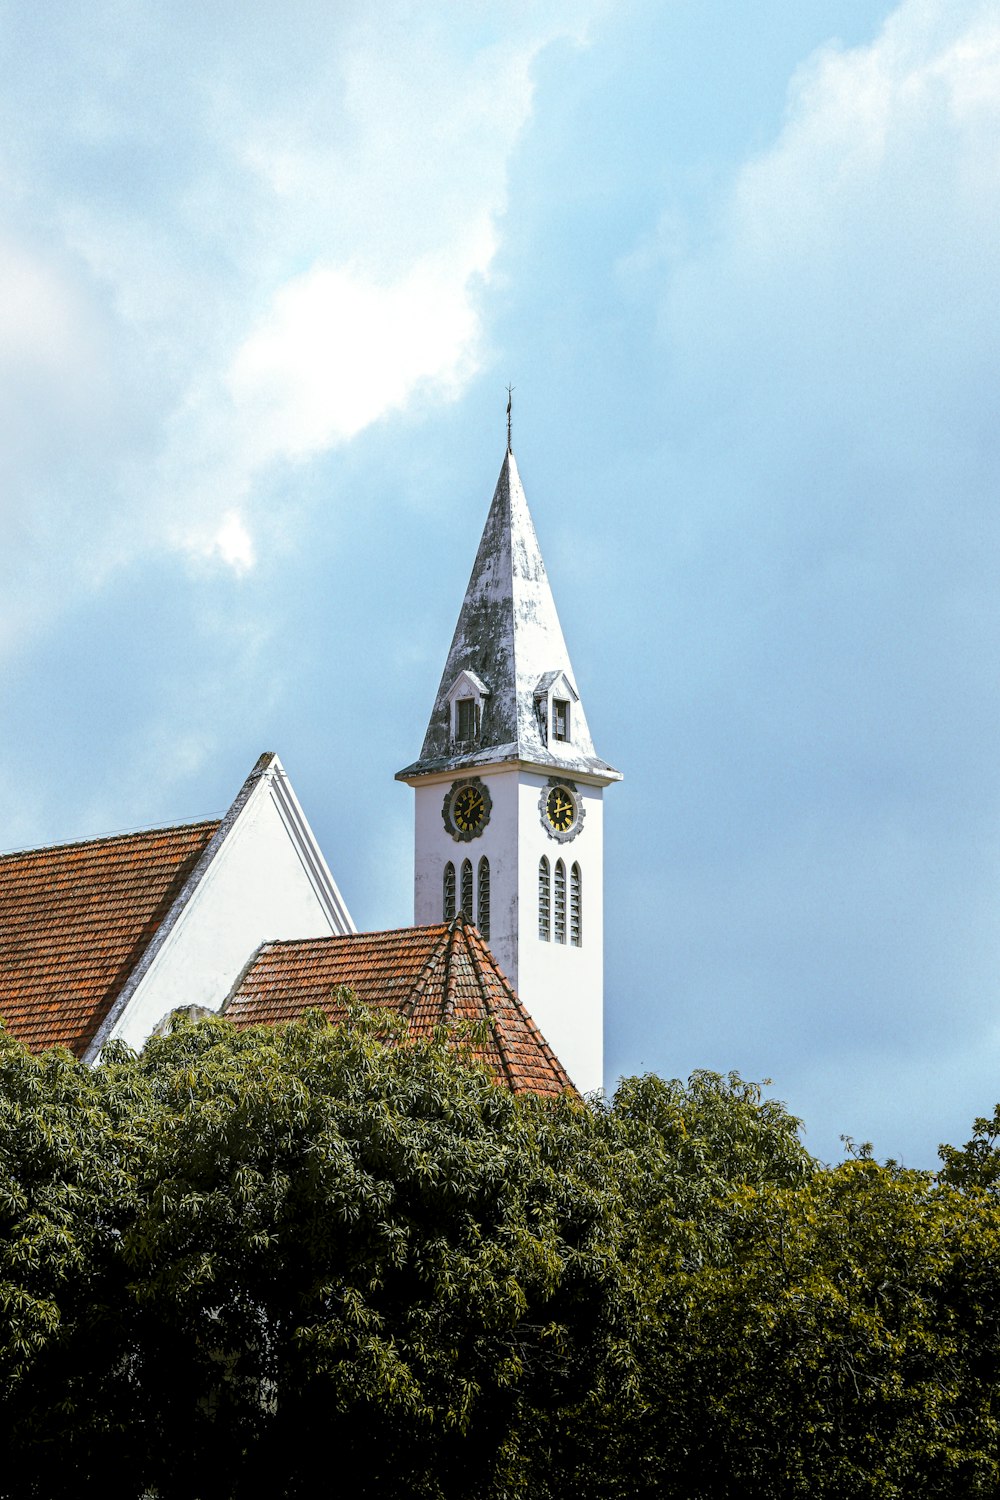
[0,0,1000,1167]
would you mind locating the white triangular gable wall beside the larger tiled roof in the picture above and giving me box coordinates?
[111,773,352,1047]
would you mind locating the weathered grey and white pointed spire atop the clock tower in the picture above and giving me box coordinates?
[399,452,619,782]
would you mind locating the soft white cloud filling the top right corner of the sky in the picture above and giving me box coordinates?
[667,0,1000,402]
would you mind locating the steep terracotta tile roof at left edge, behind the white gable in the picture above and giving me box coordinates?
[0,822,219,1055]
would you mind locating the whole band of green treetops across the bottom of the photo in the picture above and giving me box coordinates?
[0,1013,1000,1500]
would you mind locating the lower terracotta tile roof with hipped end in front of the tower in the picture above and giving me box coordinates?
[225,917,573,1095]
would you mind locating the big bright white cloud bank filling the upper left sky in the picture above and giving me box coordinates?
[0,0,593,627]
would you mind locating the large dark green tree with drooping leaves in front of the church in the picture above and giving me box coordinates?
[4,1016,628,1500]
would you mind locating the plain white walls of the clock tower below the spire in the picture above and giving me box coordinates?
[414,767,604,1092]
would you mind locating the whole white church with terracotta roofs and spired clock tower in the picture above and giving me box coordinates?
[0,444,621,1095]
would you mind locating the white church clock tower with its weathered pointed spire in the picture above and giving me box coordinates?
[397,447,621,1092]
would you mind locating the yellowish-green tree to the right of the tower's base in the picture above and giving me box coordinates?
[599,1074,1000,1500]
